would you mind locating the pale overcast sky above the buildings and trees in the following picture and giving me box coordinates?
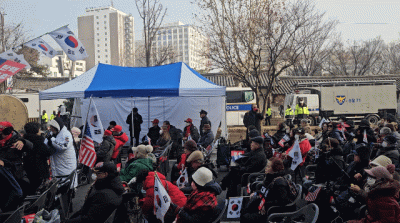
[0,0,400,45]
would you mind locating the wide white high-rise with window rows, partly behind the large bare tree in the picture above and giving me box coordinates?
[135,22,210,70]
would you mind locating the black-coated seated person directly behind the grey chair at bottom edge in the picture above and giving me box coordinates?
[240,157,297,223]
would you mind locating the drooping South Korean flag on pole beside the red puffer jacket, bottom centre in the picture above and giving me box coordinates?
[154,173,171,223]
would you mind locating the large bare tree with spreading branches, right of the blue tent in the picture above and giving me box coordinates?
[195,0,338,113]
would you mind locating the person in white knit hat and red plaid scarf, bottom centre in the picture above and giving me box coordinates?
[171,167,222,223]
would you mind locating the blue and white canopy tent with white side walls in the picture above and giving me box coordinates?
[39,62,226,141]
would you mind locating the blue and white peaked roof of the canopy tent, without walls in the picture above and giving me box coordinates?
[39,62,225,100]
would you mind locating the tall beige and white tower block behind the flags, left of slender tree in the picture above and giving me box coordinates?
[78,6,135,70]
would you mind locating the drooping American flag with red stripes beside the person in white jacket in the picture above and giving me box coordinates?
[79,123,97,168]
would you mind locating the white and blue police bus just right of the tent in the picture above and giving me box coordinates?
[226,87,256,126]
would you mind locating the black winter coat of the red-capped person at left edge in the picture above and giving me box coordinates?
[0,131,33,179]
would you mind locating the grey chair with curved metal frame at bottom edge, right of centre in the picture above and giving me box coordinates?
[268,203,319,223]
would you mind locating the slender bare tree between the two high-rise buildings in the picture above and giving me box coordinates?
[135,0,167,67]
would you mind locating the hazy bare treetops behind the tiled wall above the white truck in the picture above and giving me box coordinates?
[324,37,386,76]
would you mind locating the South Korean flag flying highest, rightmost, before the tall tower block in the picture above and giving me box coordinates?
[49,26,88,61]
